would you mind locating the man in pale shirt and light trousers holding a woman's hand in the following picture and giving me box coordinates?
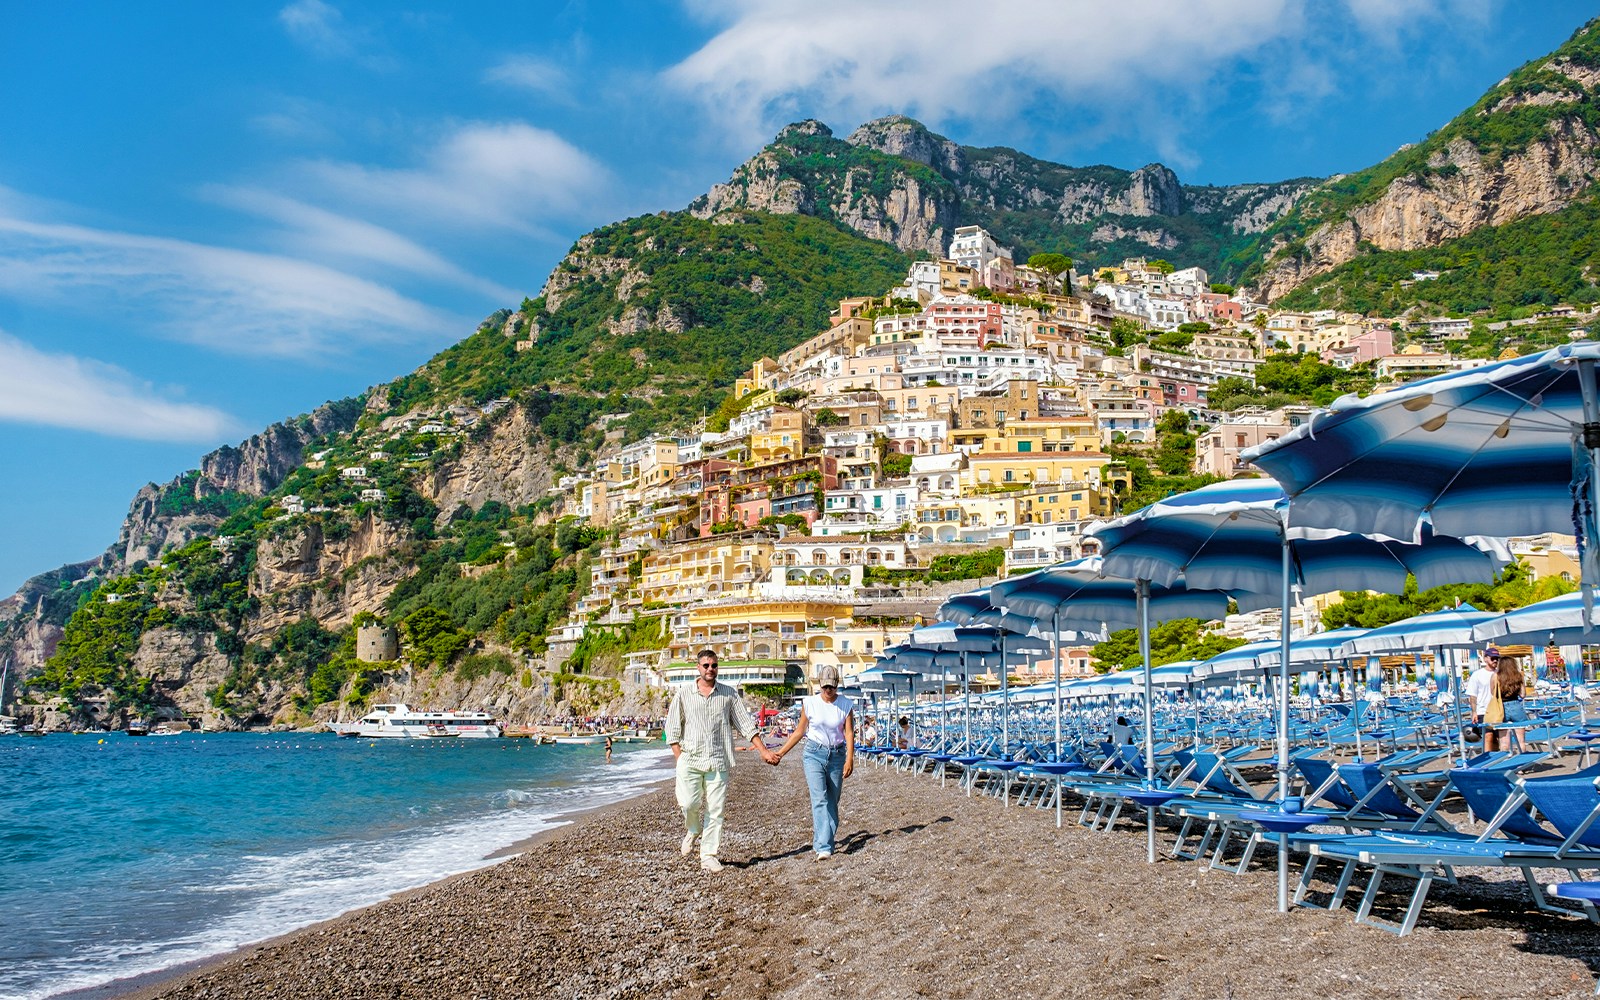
[667,650,778,872]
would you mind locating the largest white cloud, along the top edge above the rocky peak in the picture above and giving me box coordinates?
[664,0,1472,147]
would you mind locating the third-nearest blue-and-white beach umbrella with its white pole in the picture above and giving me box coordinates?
[989,557,1227,864]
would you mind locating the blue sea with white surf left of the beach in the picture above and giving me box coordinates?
[0,733,672,1000]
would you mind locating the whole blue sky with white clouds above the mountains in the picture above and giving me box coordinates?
[0,0,1595,595]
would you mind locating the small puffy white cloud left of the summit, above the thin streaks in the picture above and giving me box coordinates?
[306,122,610,232]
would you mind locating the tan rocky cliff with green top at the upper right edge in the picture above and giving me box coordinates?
[1243,21,1600,301]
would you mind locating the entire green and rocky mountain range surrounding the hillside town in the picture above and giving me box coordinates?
[15,26,1600,726]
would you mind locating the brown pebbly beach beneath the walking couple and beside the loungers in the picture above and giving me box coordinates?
[85,754,1600,1000]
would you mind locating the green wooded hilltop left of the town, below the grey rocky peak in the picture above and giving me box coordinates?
[377,213,910,442]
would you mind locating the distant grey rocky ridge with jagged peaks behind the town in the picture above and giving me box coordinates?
[690,115,1317,280]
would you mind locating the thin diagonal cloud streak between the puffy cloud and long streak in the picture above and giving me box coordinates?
[205,186,522,302]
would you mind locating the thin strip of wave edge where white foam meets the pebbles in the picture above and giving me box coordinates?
[45,755,672,1000]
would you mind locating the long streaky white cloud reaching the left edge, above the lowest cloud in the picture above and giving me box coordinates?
[0,216,462,357]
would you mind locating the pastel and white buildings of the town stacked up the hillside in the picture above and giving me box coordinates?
[492,226,1570,688]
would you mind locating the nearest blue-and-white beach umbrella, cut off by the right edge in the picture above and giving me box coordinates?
[1240,342,1600,621]
